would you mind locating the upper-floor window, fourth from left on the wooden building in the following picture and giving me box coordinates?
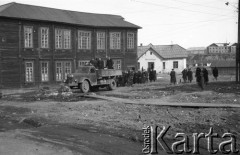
[78,31,91,49]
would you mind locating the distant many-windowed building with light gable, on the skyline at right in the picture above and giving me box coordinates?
[207,43,230,54]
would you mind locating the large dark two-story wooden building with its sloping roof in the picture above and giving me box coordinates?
[0,3,141,87]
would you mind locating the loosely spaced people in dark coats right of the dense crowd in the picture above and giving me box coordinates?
[170,67,218,89]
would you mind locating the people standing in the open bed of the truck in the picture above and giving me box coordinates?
[90,57,114,69]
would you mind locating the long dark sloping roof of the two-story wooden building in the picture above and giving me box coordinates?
[0,2,141,29]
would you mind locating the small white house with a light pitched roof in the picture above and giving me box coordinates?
[138,44,188,73]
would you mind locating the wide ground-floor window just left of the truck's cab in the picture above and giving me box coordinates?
[56,61,72,81]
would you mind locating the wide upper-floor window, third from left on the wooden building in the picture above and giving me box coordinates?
[55,29,71,49]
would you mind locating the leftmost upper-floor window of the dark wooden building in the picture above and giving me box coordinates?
[24,26,33,48]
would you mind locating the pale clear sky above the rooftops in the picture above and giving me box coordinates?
[0,0,238,49]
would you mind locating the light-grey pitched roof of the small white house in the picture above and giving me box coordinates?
[138,44,188,59]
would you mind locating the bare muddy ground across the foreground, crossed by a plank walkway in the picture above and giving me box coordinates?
[0,74,240,155]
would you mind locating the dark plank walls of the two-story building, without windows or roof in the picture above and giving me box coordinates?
[0,17,137,87]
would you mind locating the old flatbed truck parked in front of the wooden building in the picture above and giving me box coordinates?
[65,65,122,93]
